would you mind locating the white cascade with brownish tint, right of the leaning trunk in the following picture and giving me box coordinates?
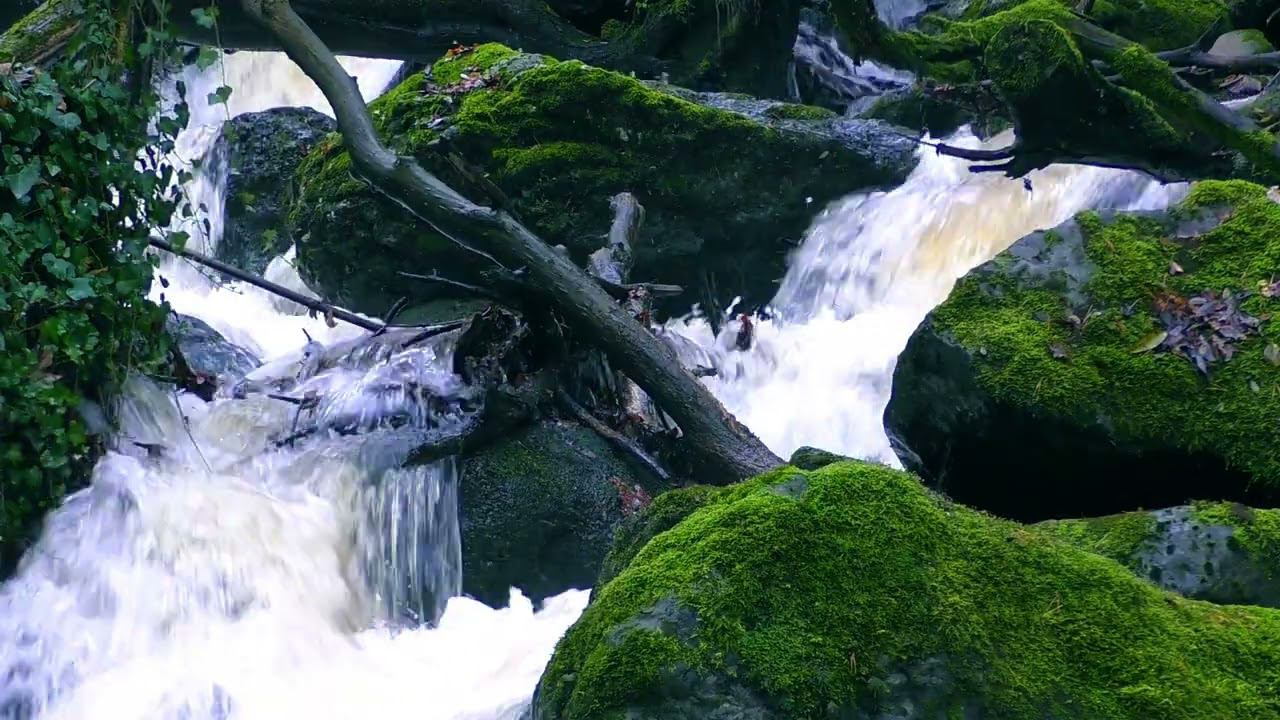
[666,131,1185,466]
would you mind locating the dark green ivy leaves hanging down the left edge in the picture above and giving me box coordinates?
[0,0,182,555]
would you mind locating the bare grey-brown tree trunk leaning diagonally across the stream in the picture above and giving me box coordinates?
[242,0,782,483]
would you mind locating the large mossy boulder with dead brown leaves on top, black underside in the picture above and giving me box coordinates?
[886,181,1280,519]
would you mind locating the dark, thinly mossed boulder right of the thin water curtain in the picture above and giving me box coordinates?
[460,420,667,607]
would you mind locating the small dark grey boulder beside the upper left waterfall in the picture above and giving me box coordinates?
[214,108,337,275]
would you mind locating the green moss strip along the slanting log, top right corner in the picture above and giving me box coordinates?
[1111,46,1280,176]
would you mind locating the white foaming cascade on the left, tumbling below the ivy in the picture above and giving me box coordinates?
[0,53,588,720]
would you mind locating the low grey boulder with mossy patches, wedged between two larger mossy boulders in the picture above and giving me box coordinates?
[1036,502,1280,607]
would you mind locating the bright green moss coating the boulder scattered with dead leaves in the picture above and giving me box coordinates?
[934,182,1280,484]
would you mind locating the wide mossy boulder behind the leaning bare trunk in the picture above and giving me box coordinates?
[293,45,915,313]
